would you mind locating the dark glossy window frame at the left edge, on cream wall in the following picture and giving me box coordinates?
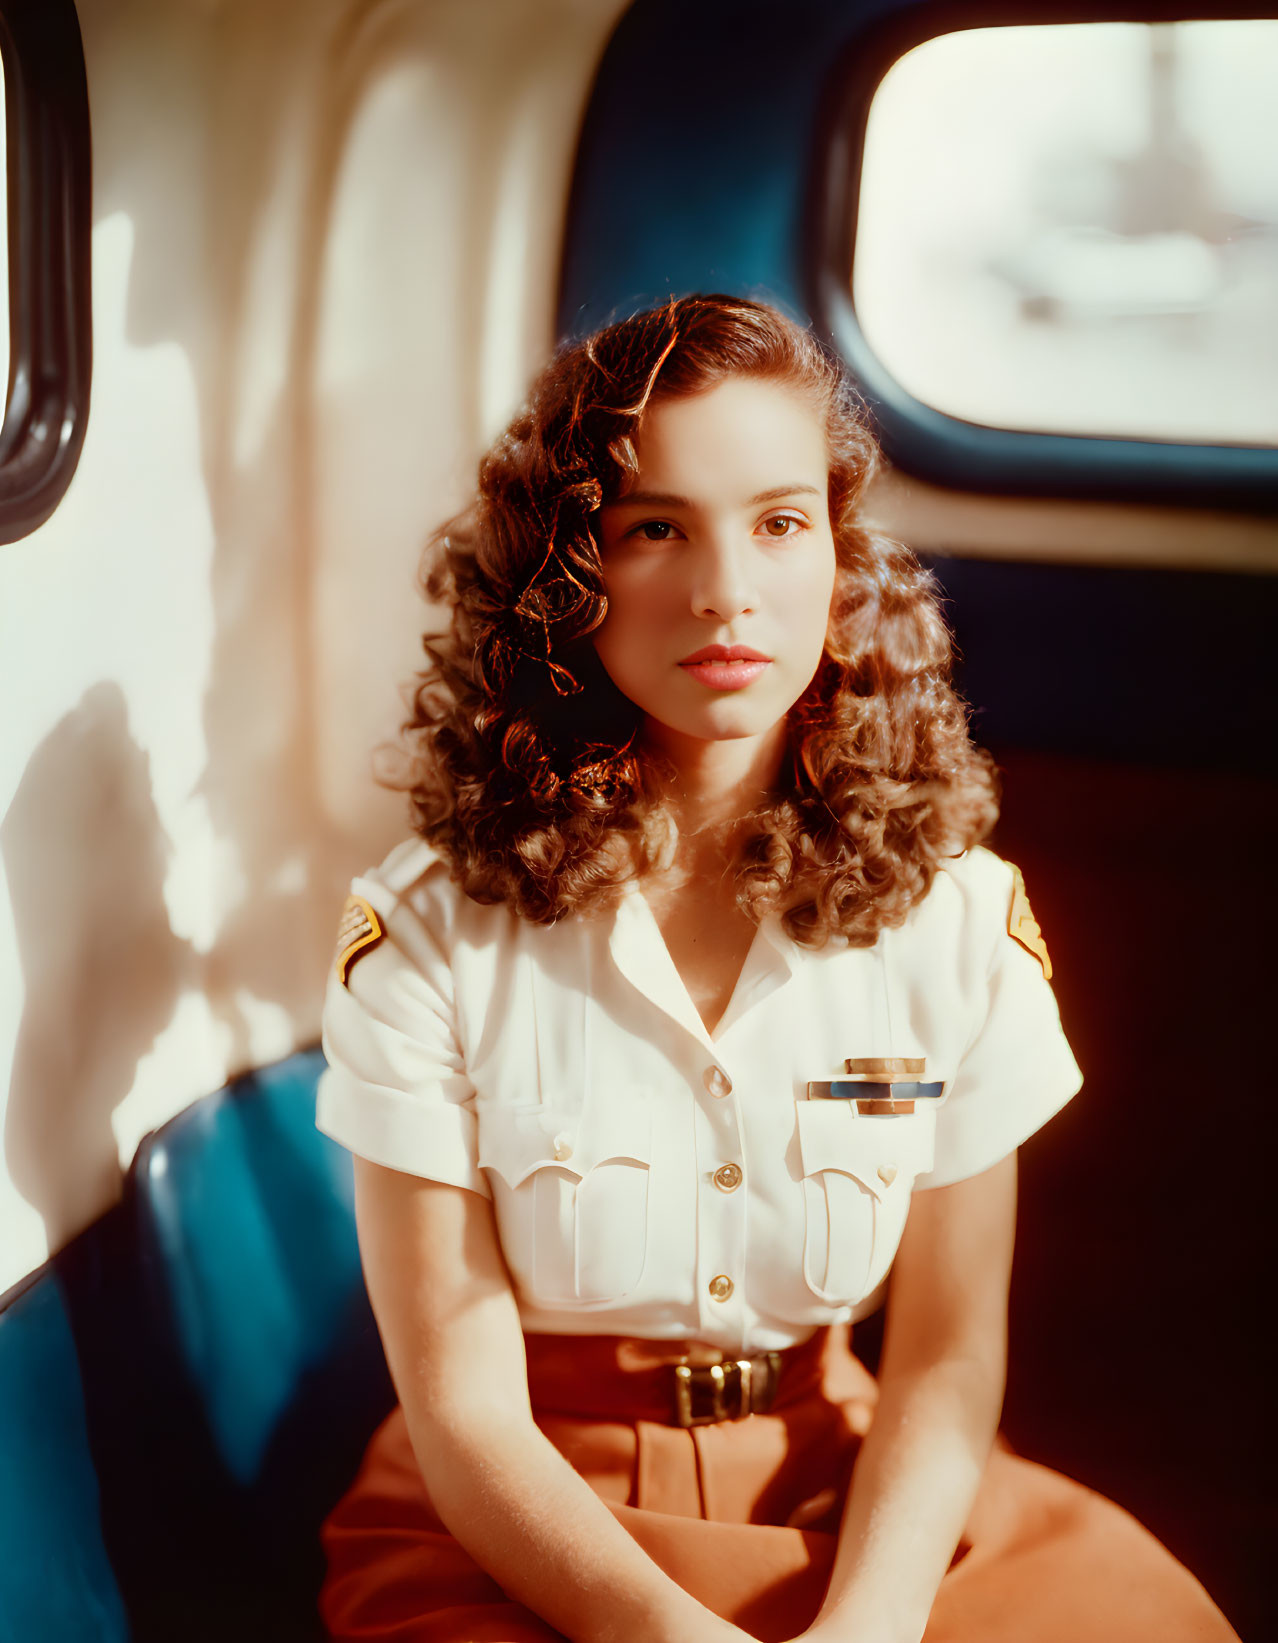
[0,0,92,542]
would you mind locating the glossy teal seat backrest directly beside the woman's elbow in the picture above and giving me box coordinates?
[133,1050,393,1584]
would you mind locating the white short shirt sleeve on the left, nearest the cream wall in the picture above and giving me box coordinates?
[315,858,491,1198]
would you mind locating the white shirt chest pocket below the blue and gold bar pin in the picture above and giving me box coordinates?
[795,1101,936,1306]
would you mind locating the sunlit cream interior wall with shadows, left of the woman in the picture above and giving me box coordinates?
[0,0,621,1288]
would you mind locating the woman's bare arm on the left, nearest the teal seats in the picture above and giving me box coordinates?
[355,1158,746,1643]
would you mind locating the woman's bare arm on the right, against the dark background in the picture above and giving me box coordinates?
[803,1153,1017,1643]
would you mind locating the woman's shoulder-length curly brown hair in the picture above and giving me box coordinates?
[389,296,997,946]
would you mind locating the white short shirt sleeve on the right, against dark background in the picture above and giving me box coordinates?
[915,849,1083,1188]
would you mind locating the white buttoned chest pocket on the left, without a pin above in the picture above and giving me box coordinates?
[480,1094,652,1306]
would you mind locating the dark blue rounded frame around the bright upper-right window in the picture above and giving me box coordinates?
[807,0,1278,513]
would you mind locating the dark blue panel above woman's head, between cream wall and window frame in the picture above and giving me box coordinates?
[560,0,854,335]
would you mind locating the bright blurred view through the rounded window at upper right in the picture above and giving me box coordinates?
[853,21,1278,445]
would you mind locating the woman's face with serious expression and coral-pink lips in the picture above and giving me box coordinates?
[595,376,834,752]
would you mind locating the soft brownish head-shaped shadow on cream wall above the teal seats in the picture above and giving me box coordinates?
[0,683,195,1249]
